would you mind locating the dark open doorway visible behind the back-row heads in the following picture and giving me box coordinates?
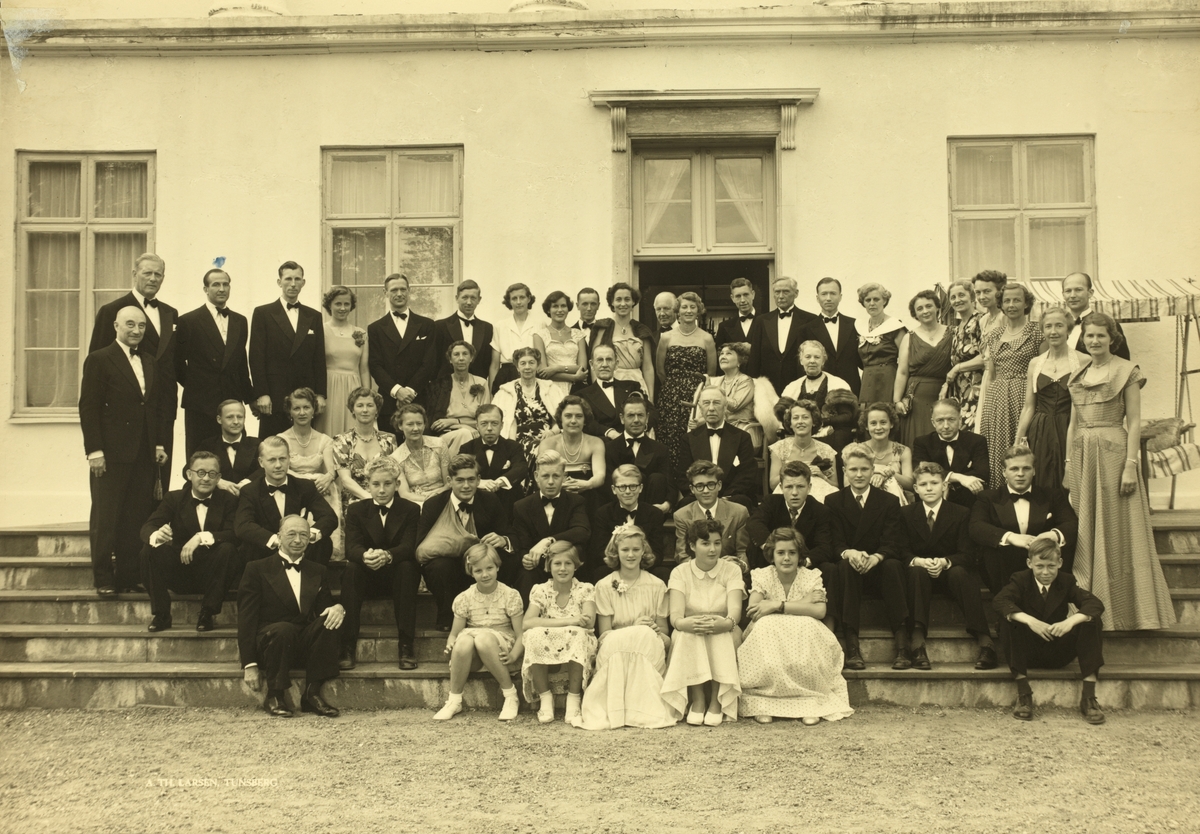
[637,260,772,332]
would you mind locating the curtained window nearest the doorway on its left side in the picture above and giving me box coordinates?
[323,148,462,326]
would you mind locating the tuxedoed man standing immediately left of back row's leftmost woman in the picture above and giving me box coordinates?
[250,260,326,437]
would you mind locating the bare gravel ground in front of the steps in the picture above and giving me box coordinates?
[0,707,1200,834]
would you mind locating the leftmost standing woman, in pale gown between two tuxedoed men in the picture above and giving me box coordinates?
[313,284,371,437]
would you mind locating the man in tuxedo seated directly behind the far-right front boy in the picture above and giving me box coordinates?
[971,446,1079,594]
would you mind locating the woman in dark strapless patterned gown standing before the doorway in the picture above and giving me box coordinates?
[656,293,716,468]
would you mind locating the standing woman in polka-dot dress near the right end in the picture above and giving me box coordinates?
[979,283,1044,490]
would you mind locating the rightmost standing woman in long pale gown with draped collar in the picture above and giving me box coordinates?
[1067,313,1175,631]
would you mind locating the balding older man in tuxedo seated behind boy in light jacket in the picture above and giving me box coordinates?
[676,388,762,509]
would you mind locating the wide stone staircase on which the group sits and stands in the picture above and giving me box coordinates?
[0,511,1200,709]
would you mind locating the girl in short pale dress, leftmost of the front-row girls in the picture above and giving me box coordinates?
[433,542,524,721]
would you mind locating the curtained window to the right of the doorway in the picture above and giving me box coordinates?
[949,136,1098,281]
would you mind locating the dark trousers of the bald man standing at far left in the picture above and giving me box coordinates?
[88,444,157,589]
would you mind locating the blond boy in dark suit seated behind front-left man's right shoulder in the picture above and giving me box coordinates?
[337,457,421,670]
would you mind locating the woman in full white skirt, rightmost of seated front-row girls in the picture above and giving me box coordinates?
[738,527,854,727]
